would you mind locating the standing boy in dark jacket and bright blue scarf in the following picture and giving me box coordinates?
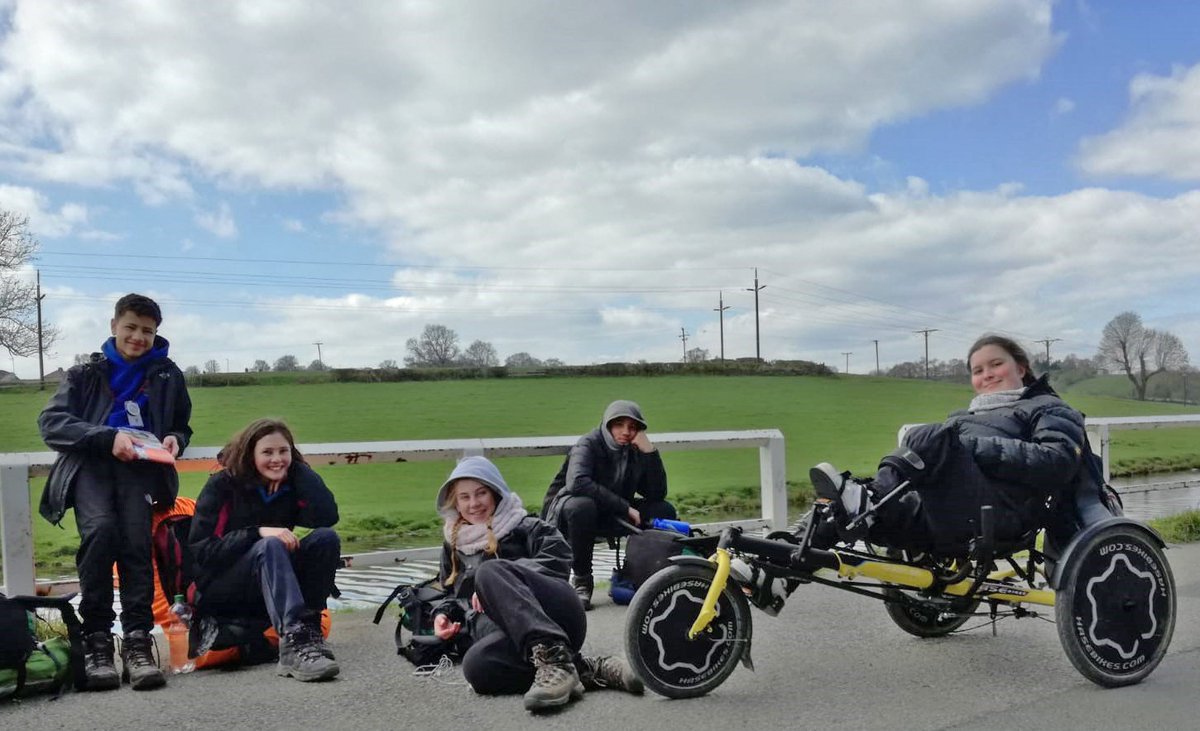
[37,294,192,690]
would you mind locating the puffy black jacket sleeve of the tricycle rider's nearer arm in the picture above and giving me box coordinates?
[960,402,1085,484]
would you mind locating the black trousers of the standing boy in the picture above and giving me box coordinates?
[72,459,162,634]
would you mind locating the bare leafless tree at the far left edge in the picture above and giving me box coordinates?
[0,210,59,356]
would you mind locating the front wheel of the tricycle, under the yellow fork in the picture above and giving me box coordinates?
[625,564,752,699]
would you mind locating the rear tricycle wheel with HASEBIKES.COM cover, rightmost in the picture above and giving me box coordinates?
[1055,523,1176,688]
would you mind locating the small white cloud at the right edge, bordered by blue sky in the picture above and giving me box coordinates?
[1079,64,1200,180]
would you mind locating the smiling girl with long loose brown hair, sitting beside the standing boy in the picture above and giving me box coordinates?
[188,419,341,681]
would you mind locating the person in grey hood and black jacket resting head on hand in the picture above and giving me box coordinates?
[542,401,677,610]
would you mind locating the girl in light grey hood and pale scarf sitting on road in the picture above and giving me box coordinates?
[432,456,643,711]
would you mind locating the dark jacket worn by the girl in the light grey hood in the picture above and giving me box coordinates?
[433,515,571,640]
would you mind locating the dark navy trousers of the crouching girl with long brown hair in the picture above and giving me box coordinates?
[199,528,342,636]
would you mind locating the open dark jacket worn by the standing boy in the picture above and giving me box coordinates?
[37,348,192,525]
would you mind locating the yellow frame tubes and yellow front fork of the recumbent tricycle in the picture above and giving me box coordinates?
[688,549,1054,640]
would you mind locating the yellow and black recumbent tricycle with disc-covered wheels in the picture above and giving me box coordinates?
[625,460,1176,699]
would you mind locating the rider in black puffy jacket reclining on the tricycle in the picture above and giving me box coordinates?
[809,335,1086,553]
